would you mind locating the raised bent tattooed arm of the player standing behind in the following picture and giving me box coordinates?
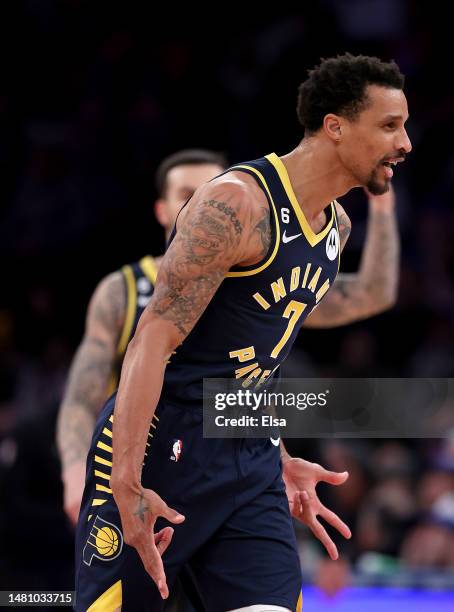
[304,187,399,327]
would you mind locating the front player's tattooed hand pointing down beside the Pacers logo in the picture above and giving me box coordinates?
[112,485,185,599]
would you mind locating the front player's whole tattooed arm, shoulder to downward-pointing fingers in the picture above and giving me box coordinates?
[110,177,263,598]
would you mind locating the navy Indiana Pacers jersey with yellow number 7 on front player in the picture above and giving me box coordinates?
[161,153,340,405]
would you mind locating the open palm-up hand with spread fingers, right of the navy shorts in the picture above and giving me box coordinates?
[282,457,352,561]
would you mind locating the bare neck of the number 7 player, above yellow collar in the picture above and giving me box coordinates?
[281,137,354,221]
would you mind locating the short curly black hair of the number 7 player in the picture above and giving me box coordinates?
[296,53,405,135]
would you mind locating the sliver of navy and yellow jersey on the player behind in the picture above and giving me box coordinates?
[109,255,158,395]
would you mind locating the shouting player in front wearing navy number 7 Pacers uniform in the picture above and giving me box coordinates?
[76,55,411,611]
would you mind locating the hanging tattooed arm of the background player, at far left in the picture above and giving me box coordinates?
[57,272,126,523]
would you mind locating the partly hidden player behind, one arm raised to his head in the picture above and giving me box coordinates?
[58,158,399,524]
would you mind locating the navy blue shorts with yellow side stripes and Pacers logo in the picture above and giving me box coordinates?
[75,396,301,612]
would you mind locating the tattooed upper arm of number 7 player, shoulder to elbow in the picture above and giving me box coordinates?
[139,188,251,345]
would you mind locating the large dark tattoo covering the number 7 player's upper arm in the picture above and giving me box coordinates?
[149,200,243,336]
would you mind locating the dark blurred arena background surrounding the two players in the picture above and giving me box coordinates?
[0,0,454,589]
